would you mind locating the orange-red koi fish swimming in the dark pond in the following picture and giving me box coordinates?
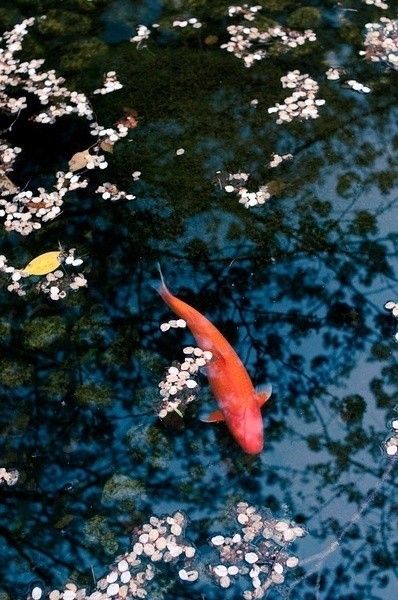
[157,266,272,454]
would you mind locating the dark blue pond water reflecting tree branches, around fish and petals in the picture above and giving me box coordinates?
[0,2,398,599]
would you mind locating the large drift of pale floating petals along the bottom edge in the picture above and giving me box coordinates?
[27,502,305,600]
